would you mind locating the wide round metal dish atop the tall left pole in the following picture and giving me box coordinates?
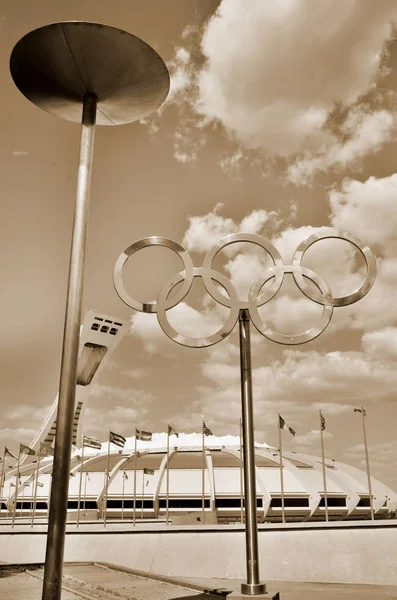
[10,21,170,125]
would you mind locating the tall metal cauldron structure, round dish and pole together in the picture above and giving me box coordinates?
[10,21,169,600]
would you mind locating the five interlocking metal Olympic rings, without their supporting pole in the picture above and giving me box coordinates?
[113,229,377,348]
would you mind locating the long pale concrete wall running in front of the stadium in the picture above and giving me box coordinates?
[0,520,397,585]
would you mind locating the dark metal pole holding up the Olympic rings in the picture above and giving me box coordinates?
[239,309,266,596]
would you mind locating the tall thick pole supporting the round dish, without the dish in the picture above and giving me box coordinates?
[42,93,97,600]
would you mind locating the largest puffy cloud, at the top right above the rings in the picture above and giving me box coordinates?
[170,0,396,184]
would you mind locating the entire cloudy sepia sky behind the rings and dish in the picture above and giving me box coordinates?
[0,0,397,490]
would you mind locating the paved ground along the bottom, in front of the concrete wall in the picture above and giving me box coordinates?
[0,563,397,600]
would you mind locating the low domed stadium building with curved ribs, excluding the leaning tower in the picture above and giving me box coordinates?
[2,434,397,523]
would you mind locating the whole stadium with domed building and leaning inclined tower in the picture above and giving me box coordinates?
[1,310,397,524]
